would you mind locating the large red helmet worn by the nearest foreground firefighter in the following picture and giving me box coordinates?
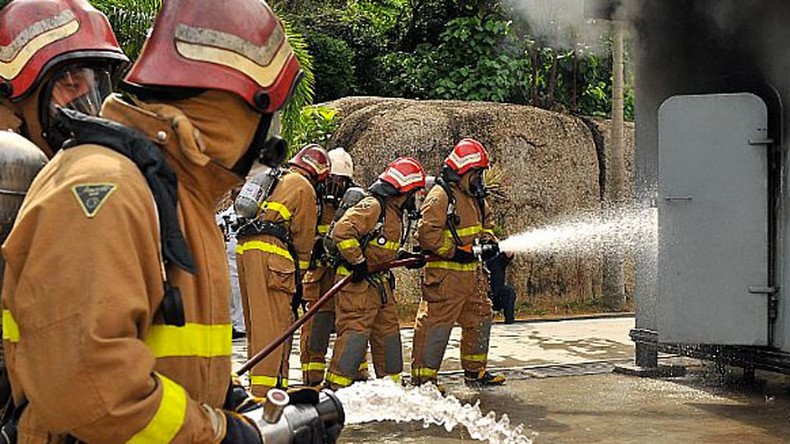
[124,0,301,113]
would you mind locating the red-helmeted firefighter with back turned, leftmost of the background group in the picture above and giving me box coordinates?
[236,144,330,396]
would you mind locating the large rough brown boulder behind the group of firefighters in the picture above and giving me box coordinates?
[326,97,633,312]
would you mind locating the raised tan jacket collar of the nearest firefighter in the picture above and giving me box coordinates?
[101,95,242,206]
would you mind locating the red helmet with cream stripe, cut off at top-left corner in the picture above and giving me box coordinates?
[0,0,129,100]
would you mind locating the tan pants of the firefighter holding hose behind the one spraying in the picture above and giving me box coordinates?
[326,281,403,389]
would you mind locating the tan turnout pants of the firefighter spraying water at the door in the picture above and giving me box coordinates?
[411,267,493,384]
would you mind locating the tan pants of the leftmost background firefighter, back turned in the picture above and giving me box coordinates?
[236,236,296,397]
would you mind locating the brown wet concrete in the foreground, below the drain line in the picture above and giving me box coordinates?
[342,374,790,443]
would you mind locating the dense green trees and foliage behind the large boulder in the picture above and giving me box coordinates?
[88,0,634,123]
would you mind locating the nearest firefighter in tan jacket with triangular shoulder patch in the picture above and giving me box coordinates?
[0,0,338,443]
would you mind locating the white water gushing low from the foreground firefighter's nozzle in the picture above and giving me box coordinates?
[337,379,532,444]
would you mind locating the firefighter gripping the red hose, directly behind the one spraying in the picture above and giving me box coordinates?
[326,157,425,389]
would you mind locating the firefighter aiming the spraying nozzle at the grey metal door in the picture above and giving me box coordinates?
[411,139,505,386]
